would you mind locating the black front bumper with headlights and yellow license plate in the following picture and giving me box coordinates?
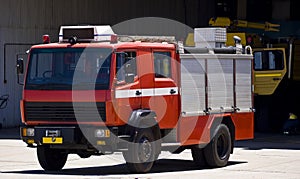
[20,126,124,153]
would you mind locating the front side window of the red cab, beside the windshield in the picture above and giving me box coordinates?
[116,52,137,82]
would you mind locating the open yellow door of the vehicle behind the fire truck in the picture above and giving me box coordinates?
[253,48,286,95]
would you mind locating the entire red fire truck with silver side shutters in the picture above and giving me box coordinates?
[17,26,254,173]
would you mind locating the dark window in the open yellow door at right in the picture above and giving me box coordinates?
[254,50,284,70]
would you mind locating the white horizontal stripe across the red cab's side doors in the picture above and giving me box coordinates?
[116,87,178,98]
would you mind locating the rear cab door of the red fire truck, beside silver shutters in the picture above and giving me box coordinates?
[151,50,179,129]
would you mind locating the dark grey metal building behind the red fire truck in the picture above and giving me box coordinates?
[0,0,300,128]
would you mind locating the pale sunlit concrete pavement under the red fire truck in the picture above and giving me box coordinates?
[0,126,300,179]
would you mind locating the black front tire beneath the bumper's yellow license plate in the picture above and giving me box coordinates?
[37,145,68,171]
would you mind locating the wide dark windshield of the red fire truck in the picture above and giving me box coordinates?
[24,47,113,90]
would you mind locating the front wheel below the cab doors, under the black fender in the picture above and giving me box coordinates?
[123,129,158,173]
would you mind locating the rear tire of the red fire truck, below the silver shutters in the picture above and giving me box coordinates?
[204,124,231,167]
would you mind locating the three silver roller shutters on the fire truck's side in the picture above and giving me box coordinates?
[180,54,252,116]
